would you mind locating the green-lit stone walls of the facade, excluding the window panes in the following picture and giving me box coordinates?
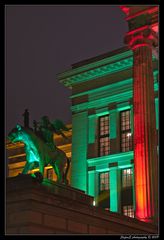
[59,43,158,219]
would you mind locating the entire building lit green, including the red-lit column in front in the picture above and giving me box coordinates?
[5,6,159,227]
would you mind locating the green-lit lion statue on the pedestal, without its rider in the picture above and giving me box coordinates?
[8,124,70,184]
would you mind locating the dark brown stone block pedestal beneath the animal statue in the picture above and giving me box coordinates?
[6,175,157,235]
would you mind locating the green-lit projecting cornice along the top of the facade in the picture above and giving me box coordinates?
[57,50,158,88]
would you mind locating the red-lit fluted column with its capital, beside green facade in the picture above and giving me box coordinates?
[125,26,158,222]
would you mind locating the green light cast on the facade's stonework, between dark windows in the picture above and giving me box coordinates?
[58,43,159,212]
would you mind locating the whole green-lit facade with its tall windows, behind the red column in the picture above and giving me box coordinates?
[58,47,159,217]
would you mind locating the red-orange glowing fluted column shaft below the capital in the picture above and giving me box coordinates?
[133,44,154,222]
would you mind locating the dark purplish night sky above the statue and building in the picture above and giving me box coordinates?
[5,5,128,133]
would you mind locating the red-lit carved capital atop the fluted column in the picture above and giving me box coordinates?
[125,26,158,50]
